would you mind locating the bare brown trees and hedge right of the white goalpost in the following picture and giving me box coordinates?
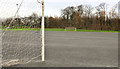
[48,3,120,31]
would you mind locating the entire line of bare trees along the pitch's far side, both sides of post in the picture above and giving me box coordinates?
[2,3,120,31]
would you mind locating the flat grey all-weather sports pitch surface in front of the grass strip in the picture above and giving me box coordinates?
[1,31,118,67]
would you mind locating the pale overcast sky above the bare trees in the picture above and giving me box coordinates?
[0,0,120,18]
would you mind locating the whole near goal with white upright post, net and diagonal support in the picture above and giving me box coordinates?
[2,0,45,66]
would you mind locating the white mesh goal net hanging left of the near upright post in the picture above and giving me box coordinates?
[1,0,42,66]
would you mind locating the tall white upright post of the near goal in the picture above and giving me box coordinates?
[41,0,45,62]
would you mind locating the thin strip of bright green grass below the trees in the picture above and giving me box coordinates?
[3,28,120,33]
